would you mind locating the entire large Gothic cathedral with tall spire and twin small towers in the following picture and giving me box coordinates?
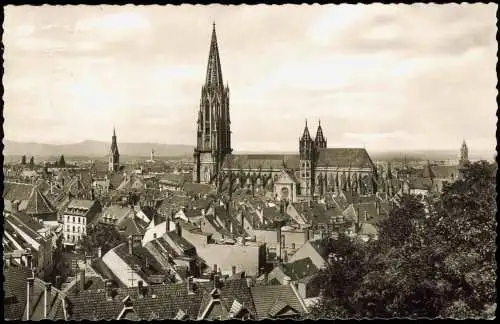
[193,24,377,202]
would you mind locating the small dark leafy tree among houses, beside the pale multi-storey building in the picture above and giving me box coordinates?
[80,224,123,255]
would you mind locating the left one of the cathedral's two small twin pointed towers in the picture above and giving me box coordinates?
[299,120,314,197]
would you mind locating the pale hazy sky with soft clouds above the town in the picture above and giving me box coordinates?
[3,4,497,152]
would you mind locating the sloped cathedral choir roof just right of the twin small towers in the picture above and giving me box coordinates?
[317,148,374,168]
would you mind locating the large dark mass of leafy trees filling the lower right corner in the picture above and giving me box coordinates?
[313,161,497,318]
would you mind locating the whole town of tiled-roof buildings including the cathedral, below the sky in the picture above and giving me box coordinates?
[2,26,468,320]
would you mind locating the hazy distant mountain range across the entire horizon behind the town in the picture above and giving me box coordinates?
[3,140,494,161]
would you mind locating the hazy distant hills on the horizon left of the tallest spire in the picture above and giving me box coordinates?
[3,140,193,157]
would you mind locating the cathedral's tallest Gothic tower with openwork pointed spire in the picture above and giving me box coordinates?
[193,23,232,183]
